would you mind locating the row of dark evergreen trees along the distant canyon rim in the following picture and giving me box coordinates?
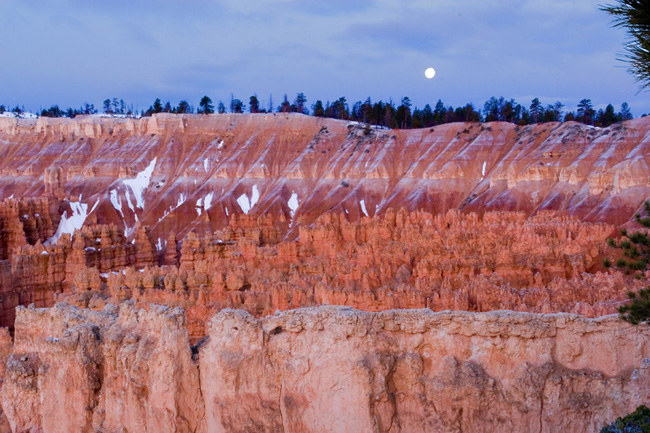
[13,93,633,129]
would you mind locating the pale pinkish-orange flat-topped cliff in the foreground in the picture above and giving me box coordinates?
[2,303,650,433]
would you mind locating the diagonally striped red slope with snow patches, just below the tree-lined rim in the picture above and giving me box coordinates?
[0,113,650,249]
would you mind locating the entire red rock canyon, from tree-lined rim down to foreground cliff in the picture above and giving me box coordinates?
[0,113,650,432]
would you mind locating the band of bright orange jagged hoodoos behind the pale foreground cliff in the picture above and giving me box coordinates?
[56,210,642,341]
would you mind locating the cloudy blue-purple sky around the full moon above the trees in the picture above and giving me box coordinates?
[0,0,650,117]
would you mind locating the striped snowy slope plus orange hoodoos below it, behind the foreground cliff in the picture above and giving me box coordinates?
[0,113,650,328]
